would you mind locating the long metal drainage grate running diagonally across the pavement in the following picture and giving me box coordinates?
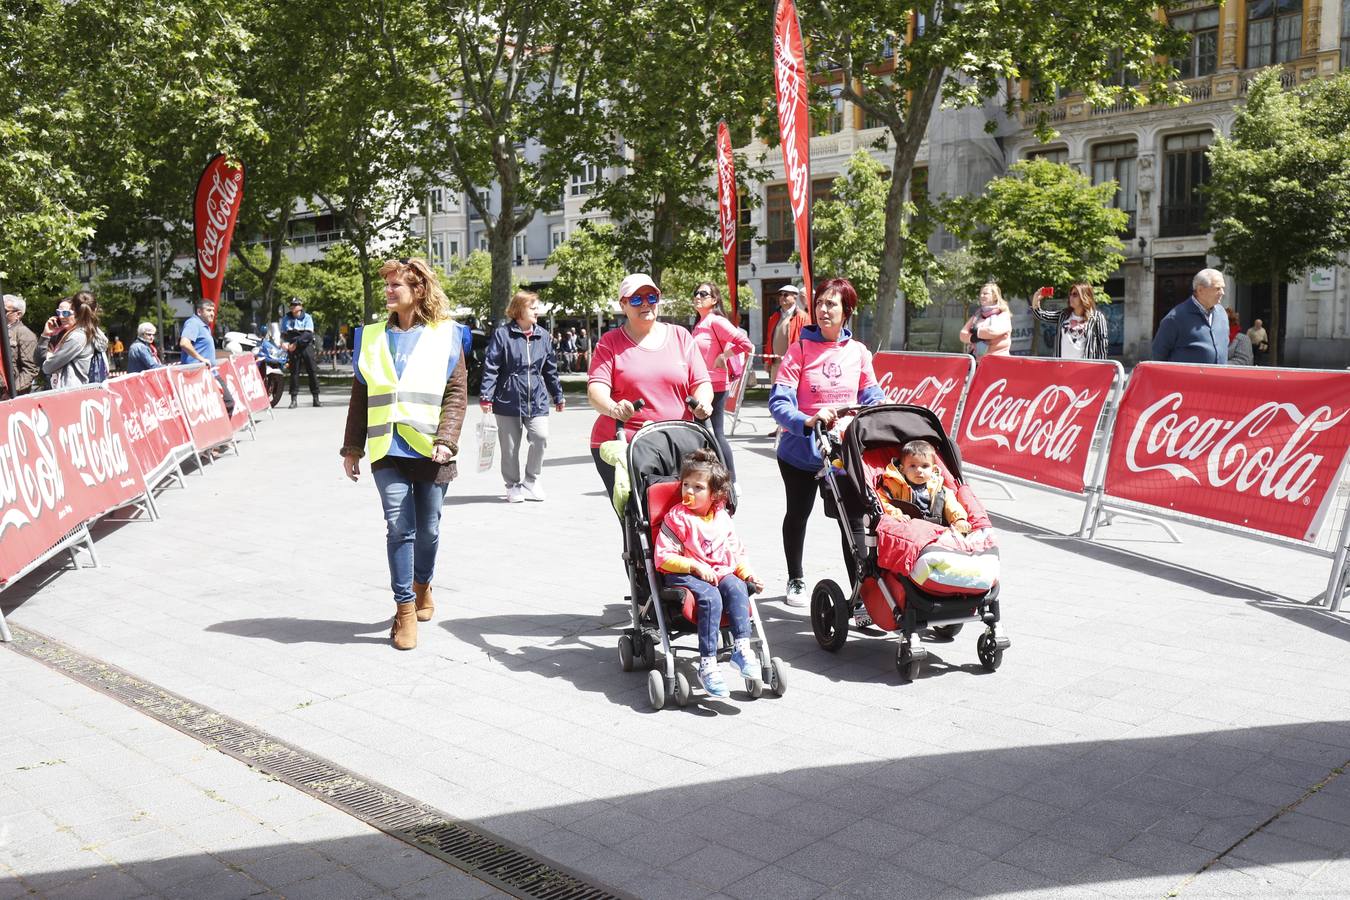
[9,625,626,900]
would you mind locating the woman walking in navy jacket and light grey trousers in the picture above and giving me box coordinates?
[478,290,564,503]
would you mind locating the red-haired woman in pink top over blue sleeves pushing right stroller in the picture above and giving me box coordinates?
[768,278,886,606]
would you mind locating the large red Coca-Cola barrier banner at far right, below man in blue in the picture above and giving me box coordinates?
[1106,363,1350,541]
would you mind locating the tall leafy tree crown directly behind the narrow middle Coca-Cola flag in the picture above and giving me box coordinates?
[586,0,774,283]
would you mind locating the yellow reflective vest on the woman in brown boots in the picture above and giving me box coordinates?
[356,318,460,463]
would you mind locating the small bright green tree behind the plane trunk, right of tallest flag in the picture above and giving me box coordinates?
[811,150,933,322]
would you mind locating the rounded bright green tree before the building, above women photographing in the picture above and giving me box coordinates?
[941,159,1130,297]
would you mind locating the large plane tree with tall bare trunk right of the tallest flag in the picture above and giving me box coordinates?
[802,0,1184,347]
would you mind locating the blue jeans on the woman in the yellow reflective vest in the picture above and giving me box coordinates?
[373,468,450,603]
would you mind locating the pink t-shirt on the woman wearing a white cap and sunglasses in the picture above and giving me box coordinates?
[586,322,709,449]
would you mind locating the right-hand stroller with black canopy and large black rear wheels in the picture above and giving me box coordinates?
[811,405,1010,681]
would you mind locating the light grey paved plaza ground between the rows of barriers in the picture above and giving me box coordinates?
[0,394,1350,900]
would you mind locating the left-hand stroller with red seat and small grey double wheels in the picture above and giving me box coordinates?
[602,421,787,710]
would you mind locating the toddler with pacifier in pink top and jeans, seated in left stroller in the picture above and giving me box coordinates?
[653,449,764,698]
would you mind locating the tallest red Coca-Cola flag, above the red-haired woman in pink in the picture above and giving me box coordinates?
[774,0,815,302]
